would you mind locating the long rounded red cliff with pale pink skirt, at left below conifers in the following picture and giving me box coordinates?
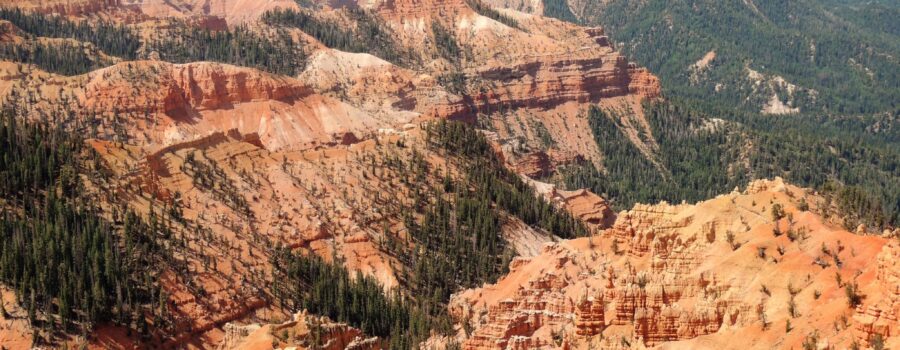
[0,61,396,150]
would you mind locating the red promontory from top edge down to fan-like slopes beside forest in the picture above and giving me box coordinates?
[350,0,660,166]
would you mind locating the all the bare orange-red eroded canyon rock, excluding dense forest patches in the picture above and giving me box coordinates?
[0,0,900,349]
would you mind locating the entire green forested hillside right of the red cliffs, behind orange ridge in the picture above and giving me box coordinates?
[532,0,900,227]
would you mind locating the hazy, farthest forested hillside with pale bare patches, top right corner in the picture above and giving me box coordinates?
[545,0,900,114]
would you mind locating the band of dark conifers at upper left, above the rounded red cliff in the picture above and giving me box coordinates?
[0,9,306,75]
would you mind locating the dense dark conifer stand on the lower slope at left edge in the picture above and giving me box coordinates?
[0,111,168,345]
